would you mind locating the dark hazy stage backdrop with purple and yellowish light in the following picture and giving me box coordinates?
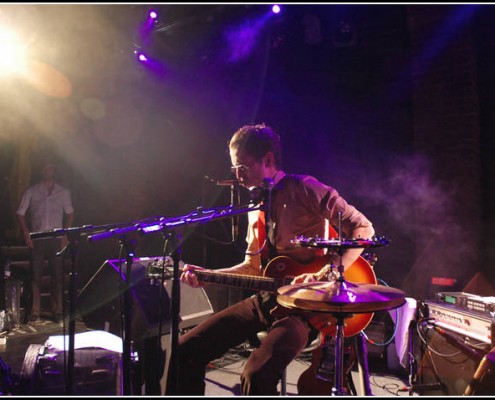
[0,4,495,298]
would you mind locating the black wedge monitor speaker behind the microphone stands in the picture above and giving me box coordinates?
[77,257,214,340]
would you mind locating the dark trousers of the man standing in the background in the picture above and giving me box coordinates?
[31,238,64,317]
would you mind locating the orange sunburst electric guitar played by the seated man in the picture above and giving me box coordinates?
[147,256,377,337]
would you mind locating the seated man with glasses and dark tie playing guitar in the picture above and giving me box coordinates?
[167,124,374,396]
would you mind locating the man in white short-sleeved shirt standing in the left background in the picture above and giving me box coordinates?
[17,159,74,323]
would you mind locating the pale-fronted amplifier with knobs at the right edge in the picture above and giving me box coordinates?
[424,300,492,344]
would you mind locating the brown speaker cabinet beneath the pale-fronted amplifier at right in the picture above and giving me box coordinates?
[418,331,494,396]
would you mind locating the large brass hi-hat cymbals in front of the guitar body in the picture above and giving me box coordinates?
[277,280,406,313]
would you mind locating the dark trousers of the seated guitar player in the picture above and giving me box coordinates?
[166,295,312,395]
